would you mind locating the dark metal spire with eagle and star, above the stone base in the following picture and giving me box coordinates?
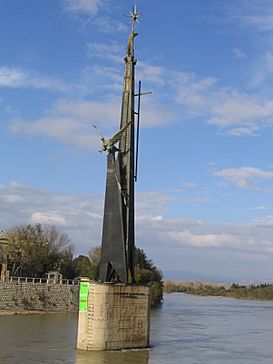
[98,5,141,284]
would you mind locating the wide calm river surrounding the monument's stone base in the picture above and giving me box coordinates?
[0,293,273,364]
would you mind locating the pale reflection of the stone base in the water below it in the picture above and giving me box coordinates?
[75,350,149,364]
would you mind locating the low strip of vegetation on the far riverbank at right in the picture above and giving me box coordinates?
[164,281,273,301]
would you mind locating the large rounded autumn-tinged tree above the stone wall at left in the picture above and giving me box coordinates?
[7,224,73,277]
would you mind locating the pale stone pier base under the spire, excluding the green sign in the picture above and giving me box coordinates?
[77,283,150,350]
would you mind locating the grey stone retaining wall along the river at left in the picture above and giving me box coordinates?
[0,281,79,312]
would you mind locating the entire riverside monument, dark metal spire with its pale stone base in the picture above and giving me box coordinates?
[77,5,150,350]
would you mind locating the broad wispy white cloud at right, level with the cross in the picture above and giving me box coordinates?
[169,72,273,136]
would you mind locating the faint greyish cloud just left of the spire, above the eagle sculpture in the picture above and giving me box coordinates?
[10,100,119,151]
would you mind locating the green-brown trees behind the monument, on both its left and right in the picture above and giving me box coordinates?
[3,224,163,306]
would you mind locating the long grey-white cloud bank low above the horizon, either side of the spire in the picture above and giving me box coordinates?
[0,182,273,279]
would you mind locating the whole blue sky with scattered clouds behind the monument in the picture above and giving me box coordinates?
[0,0,273,282]
